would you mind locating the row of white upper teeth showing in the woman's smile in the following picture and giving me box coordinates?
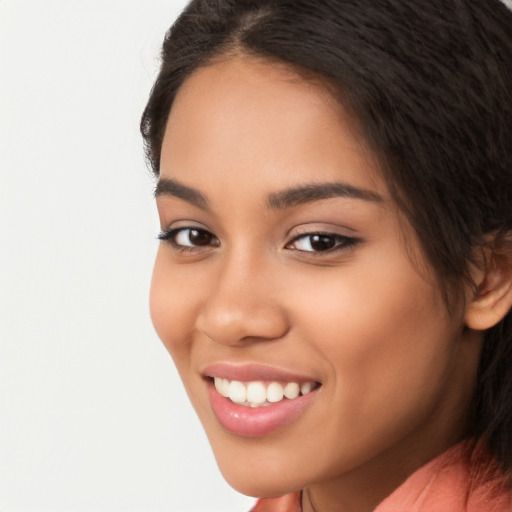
[214,377,316,407]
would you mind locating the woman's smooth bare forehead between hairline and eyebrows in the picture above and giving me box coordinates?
[161,57,386,200]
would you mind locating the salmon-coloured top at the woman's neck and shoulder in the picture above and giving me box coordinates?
[251,440,512,512]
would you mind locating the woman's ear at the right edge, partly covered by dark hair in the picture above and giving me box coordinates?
[464,237,512,331]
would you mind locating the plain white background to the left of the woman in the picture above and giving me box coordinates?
[0,0,254,512]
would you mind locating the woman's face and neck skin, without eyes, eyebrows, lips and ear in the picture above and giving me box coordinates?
[151,57,481,512]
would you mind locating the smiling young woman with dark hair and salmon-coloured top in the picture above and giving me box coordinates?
[142,0,512,512]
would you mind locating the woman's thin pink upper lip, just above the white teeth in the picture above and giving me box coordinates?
[201,362,318,383]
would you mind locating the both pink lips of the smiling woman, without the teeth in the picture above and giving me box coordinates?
[203,363,318,437]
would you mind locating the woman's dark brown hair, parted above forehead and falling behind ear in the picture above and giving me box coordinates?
[141,0,512,471]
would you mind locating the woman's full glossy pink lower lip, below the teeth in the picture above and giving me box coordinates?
[208,381,316,437]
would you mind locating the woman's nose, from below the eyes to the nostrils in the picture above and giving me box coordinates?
[196,251,289,346]
